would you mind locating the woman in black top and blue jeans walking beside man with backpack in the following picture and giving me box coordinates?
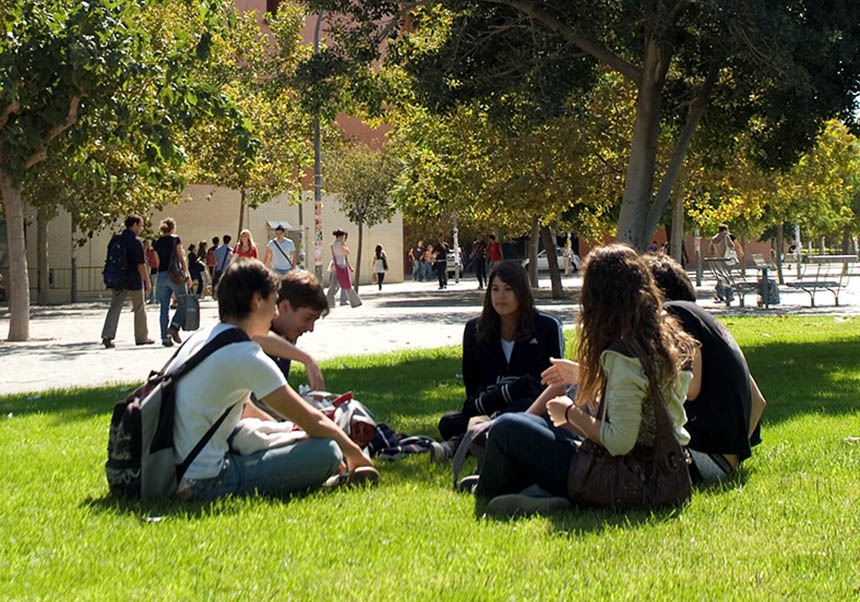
[152,217,191,347]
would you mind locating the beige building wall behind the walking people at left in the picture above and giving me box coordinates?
[21,184,404,303]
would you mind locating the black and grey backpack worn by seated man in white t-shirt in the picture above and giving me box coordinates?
[105,328,249,499]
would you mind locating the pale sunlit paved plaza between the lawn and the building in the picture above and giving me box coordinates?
[0,270,860,395]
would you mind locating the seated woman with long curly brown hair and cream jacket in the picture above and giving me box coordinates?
[475,245,697,515]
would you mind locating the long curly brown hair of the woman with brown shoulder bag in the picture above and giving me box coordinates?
[577,245,697,403]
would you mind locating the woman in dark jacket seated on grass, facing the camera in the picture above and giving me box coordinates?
[431,262,564,461]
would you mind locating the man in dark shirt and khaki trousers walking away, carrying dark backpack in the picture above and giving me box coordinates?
[102,215,154,348]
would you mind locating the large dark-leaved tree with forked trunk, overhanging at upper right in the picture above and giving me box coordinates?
[309,0,860,249]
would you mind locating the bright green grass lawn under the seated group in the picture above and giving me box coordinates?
[0,316,860,601]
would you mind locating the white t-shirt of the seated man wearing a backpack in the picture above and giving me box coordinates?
[167,324,287,479]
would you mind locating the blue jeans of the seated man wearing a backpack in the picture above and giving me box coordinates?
[191,439,343,500]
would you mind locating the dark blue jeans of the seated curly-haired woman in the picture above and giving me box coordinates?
[475,412,579,498]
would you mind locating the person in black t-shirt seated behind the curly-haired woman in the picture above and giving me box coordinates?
[644,253,765,481]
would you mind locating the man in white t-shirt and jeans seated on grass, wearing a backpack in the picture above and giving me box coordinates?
[173,260,378,500]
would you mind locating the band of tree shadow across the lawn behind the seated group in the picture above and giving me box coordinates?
[5,340,860,436]
